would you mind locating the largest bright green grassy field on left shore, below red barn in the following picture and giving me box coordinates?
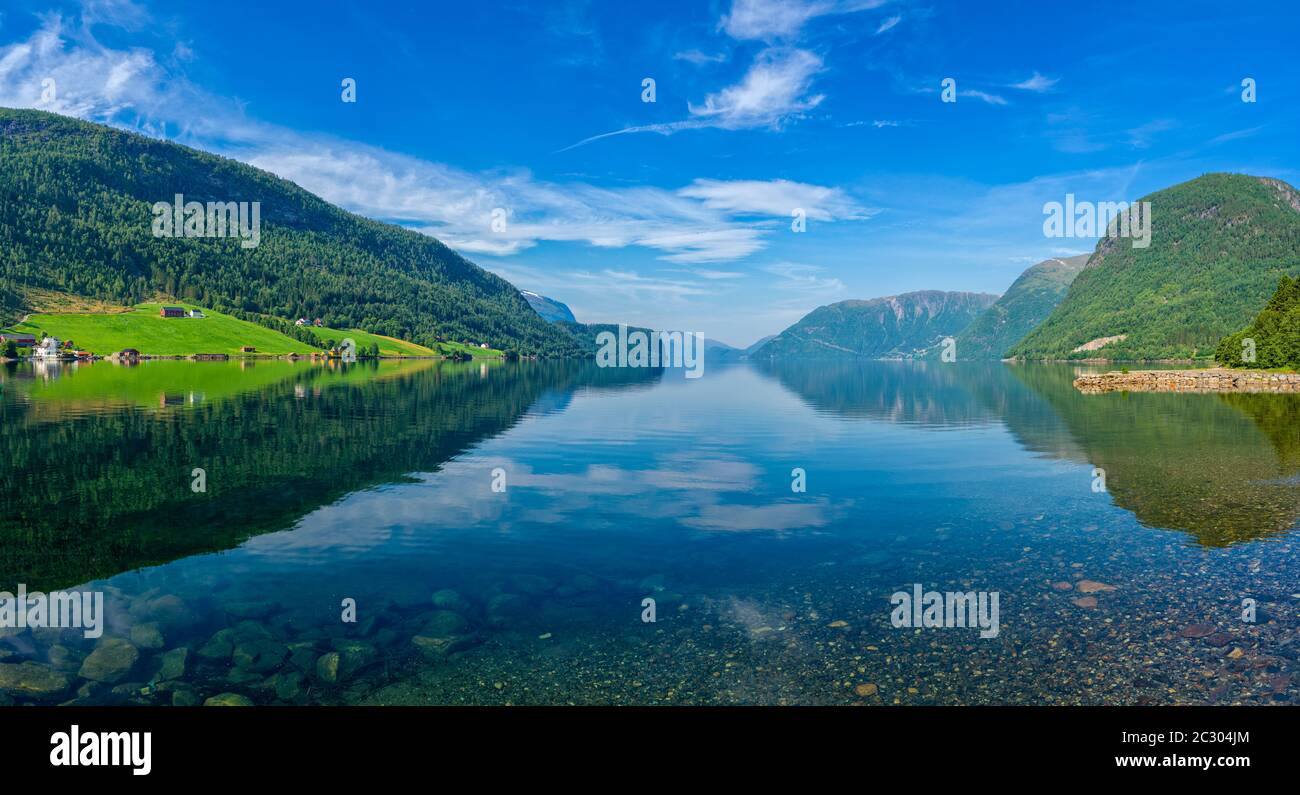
[7,303,316,356]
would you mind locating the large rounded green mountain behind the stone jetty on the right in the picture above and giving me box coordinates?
[1008,174,1300,360]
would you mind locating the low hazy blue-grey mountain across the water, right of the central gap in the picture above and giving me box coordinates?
[750,290,997,359]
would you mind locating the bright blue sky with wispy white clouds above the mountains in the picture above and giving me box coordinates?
[0,0,1300,346]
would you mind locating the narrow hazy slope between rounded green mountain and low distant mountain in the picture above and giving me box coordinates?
[957,255,1088,360]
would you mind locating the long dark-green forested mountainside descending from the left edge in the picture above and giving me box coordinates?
[0,109,577,355]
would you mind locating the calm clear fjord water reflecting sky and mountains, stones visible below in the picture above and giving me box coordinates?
[0,361,1300,704]
